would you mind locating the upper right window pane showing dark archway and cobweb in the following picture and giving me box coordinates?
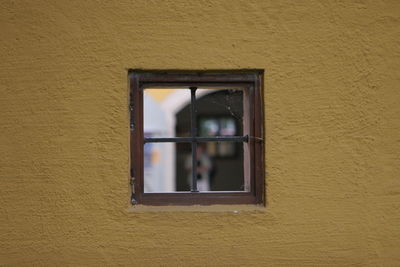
[196,89,243,136]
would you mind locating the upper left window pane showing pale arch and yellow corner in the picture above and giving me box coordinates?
[143,88,190,137]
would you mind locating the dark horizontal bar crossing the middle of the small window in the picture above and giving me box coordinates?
[144,135,249,143]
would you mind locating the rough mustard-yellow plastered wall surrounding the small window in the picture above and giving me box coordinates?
[0,0,400,266]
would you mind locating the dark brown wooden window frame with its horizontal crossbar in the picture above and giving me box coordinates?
[129,70,265,205]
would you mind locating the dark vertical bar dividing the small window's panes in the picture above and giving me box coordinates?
[189,87,199,192]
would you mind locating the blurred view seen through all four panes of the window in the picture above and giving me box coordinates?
[144,88,245,193]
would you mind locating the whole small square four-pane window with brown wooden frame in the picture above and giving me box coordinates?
[129,70,265,205]
